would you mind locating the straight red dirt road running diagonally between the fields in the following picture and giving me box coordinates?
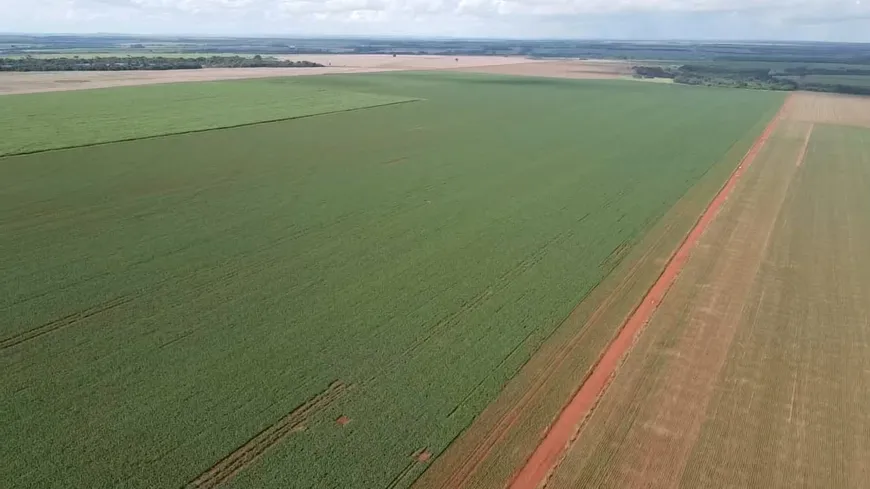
[510,97,792,489]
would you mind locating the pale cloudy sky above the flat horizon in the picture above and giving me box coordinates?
[0,0,870,42]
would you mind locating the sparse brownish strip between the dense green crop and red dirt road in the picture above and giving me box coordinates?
[414,91,784,489]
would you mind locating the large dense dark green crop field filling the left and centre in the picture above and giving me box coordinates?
[0,73,782,488]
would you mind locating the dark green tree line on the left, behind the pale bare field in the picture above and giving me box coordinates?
[0,54,323,71]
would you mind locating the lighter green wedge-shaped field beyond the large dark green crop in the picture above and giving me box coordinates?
[0,79,415,156]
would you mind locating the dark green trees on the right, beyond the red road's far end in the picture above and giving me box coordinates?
[634,61,870,95]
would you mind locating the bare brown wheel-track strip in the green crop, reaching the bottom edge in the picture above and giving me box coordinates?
[189,381,350,489]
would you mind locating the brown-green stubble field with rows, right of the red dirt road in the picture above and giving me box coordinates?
[546,94,870,488]
